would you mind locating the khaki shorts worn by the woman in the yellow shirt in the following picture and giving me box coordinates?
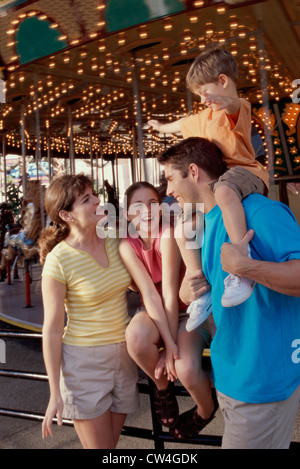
[60,342,139,419]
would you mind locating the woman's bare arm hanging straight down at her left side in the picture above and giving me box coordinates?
[42,275,66,438]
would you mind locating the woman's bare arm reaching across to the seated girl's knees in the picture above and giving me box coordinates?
[119,240,178,376]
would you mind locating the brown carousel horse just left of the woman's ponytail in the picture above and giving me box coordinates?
[0,181,44,278]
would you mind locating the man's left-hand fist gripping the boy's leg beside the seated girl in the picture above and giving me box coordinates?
[179,270,210,305]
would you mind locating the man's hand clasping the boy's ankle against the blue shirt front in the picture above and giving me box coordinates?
[221,230,254,276]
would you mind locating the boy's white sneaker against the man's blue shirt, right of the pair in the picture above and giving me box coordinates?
[221,274,255,308]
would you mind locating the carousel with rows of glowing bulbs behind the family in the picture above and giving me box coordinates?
[0,0,300,331]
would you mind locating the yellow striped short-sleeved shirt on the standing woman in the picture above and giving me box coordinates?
[43,237,131,346]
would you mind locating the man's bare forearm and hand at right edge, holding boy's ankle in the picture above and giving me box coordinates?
[221,230,300,297]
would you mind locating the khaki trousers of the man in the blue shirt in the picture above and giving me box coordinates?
[217,386,300,449]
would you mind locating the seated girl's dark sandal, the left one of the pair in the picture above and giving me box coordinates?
[151,381,179,427]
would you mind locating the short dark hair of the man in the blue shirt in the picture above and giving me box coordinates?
[157,137,227,180]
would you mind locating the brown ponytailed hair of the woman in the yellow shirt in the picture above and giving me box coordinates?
[38,173,93,265]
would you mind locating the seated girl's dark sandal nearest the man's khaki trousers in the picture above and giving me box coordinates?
[170,389,219,440]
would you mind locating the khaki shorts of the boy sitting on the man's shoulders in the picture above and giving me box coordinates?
[209,166,268,200]
